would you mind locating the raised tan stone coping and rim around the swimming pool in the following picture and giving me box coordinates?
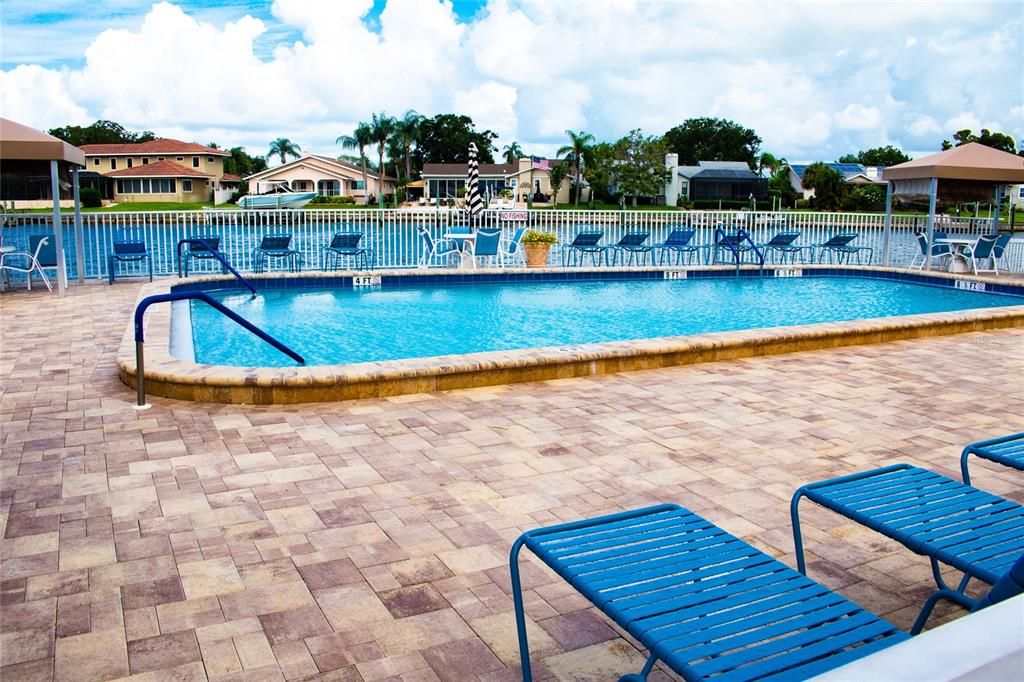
[117,265,1024,404]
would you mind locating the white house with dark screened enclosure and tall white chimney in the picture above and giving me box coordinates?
[665,154,768,206]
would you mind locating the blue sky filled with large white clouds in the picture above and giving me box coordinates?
[0,0,1024,161]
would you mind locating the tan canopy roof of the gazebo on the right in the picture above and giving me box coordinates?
[883,142,1024,184]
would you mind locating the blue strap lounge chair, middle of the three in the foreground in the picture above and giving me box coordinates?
[790,464,1024,634]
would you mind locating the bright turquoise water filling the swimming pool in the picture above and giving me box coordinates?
[191,278,1024,367]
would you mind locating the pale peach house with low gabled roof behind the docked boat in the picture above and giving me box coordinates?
[244,154,395,204]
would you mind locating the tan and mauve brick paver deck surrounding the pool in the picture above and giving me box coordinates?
[0,283,1024,681]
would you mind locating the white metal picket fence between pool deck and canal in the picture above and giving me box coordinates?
[3,208,1024,279]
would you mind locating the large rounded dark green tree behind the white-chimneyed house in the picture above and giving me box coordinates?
[665,118,761,170]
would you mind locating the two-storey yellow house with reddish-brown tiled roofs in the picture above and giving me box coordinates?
[81,137,238,203]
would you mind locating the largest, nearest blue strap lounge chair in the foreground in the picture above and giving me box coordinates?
[510,505,908,682]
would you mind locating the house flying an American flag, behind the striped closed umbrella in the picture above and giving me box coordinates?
[422,157,590,204]
